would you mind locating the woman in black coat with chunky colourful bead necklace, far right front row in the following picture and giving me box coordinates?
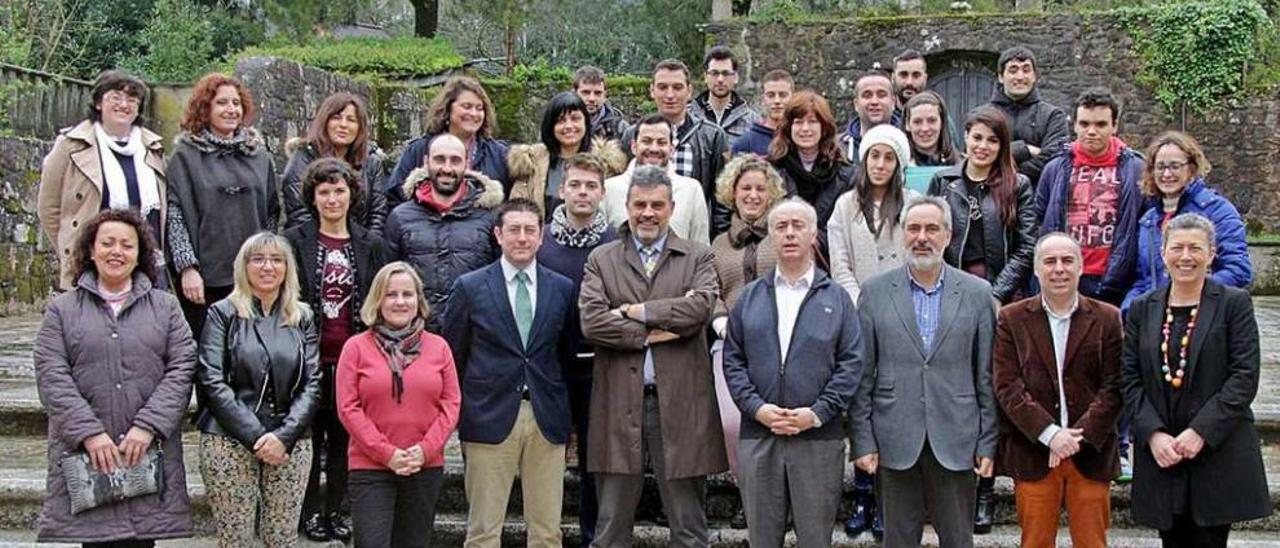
[1121,214,1271,547]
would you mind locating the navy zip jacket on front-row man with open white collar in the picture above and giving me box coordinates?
[724,269,863,439]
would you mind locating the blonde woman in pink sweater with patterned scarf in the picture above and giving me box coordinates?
[338,262,462,548]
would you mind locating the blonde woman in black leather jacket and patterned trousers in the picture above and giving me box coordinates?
[196,232,320,548]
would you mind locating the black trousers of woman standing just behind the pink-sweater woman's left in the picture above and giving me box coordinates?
[302,364,349,519]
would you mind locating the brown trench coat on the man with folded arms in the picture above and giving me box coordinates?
[579,227,728,479]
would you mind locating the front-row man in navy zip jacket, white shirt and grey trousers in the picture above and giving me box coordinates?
[724,198,863,547]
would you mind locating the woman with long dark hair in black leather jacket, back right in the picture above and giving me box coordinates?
[928,106,1038,533]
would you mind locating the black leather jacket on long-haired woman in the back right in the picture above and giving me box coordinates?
[929,163,1039,303]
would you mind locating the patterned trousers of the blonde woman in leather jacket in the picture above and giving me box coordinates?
[200,434,311,548]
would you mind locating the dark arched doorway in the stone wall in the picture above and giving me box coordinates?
[925,50,998,119]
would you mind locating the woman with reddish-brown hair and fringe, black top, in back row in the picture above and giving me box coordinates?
[769,90,854,252]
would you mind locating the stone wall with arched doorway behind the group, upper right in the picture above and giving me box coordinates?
[707,14,1280,230]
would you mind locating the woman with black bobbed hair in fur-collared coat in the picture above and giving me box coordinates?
[507,91,626,219]
